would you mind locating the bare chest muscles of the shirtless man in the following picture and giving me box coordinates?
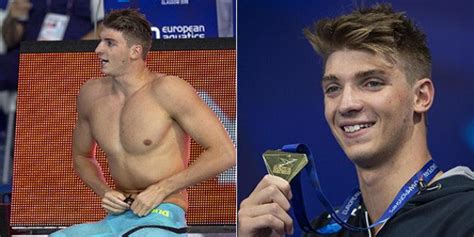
[90,91,173,155]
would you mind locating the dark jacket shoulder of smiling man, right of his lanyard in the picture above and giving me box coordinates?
[380,173,474,236]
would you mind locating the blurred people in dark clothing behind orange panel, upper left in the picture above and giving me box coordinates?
[0,0,104,185]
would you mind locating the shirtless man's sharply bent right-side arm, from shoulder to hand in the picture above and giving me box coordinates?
[132,76,236,215]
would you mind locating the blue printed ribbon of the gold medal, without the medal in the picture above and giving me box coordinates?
[281,144,440,234]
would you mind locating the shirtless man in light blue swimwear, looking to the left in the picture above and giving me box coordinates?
[52,9,235,236]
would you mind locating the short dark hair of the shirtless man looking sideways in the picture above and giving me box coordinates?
[103,9,152,59]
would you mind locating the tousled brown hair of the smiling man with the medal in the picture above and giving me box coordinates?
[304,4,431,83]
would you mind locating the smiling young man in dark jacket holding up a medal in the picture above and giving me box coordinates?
[238,4,474,236]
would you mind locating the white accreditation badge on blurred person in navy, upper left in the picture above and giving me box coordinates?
[38,12,70,41]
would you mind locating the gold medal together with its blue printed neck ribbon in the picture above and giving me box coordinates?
[263,144,439,234]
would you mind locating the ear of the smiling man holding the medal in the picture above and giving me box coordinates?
[413,78,435,113]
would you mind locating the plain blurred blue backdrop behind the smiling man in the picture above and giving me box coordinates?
[237,0,474,236]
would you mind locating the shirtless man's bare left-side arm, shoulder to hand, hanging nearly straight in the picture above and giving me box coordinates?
[72,80,129,214]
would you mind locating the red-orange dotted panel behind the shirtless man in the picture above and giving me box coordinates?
[11,40,236,226]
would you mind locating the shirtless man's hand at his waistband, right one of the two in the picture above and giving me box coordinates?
[130,183,168,217]
